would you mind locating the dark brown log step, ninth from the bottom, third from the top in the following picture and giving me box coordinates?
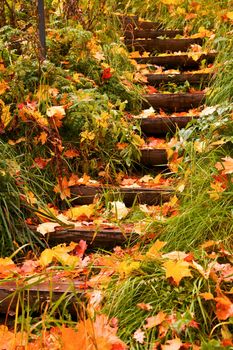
[125,38,203,53]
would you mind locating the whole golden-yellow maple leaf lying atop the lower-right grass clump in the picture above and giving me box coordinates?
[163,260,192,285]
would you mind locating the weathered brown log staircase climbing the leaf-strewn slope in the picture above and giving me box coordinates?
[0,16,216,312]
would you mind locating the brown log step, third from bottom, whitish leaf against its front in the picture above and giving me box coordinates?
[71,185,173,207]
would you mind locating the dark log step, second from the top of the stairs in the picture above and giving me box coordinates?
[124,29,183,40]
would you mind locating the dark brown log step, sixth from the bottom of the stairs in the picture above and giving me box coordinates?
[142,92,205,112]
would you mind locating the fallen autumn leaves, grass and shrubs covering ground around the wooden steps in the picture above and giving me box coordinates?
[0,0,233,350]
